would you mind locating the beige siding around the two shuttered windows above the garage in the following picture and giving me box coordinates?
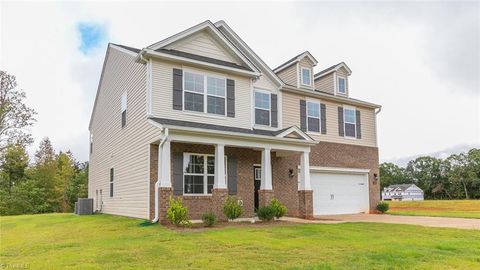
[282,92,377,147]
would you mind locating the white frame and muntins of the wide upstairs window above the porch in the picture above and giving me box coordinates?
[182,69,227,118]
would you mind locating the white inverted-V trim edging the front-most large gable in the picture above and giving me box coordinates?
[146,20,259,72]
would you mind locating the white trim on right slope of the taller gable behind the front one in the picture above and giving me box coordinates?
[215,20,284,86]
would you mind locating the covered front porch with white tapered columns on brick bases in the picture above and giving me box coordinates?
[150,121,313,223]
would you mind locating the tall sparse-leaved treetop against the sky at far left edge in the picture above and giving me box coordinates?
[0,70,36,151]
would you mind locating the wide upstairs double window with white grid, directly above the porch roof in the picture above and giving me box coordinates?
[183,72,226,115]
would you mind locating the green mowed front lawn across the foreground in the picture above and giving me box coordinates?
[0,214,480,269]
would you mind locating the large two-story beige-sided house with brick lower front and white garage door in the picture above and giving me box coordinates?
[88,21,380,222]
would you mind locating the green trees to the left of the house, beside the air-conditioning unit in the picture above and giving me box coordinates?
[0,71,88,216]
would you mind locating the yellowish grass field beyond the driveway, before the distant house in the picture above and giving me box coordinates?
[388,200,480,218]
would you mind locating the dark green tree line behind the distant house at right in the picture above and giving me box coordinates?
[380,148,480,200]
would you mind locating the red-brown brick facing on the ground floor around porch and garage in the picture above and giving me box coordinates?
[150,142,380,220]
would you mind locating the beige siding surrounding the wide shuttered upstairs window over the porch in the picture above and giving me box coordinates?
[152,60,252,128]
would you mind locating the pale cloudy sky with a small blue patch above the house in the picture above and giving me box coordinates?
[0,1,480,165]
